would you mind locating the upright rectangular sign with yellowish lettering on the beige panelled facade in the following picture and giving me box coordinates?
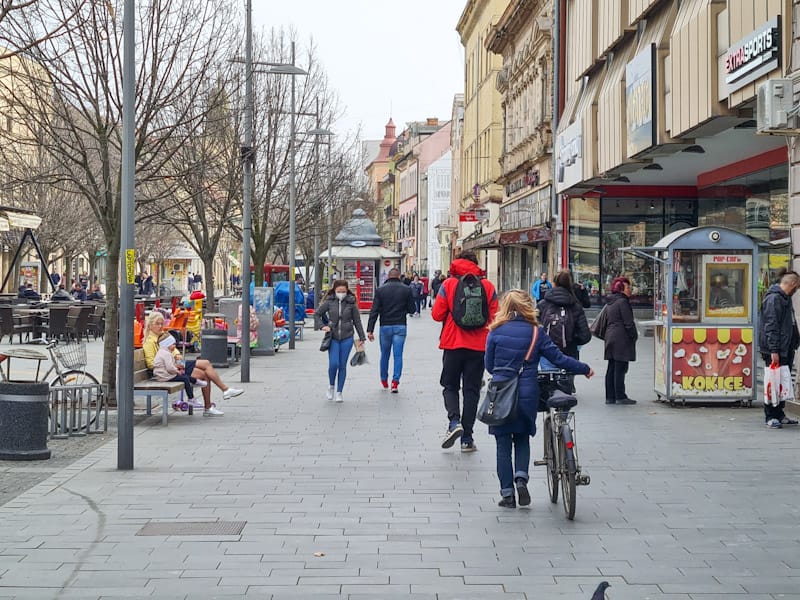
[625,44,656,158]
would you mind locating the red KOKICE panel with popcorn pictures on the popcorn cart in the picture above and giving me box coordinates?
[672,327,755,398]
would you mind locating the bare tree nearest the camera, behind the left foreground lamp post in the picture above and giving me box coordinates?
[0,0,236,404]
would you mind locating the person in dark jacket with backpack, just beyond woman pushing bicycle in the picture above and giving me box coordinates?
[537,269,592,394]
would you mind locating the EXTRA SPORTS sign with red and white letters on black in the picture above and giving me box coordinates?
[725,15,781,94]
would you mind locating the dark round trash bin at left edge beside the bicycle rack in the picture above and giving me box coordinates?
[0,381,50,460]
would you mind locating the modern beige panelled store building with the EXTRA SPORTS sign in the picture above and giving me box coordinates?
[554,0,792,307]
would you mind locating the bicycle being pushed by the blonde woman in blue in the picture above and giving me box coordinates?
[534,370,591,521]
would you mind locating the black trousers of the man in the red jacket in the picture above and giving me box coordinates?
[439,348,483,438]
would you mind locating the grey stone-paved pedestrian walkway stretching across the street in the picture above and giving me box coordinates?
[0,314,800,600]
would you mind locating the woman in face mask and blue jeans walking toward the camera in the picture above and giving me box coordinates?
[316,279,366,402]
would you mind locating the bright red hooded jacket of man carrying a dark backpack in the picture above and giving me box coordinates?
[431,258,497,352]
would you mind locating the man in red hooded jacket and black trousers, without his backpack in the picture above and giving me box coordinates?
[431,252,497,452]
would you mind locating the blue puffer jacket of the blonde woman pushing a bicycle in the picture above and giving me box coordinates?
[484,317,590,435]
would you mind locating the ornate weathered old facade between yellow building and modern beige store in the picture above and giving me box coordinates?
[486,0,555,289]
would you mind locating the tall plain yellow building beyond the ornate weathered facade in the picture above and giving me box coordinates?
[456,0,507,282]
